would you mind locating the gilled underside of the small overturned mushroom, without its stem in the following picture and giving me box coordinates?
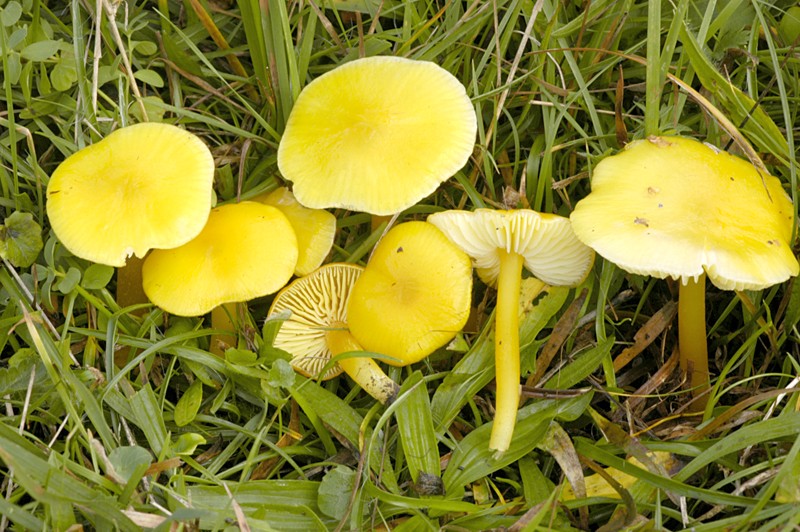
[269,263,364,380]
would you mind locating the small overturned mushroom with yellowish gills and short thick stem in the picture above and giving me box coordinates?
[269,263,399,404]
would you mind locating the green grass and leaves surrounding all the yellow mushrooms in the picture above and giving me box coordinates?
[0,0,800,530]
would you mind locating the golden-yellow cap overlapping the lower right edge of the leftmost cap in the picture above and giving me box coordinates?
[142,201,297,316]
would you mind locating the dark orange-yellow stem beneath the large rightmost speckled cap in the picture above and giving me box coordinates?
[678,275,709,396]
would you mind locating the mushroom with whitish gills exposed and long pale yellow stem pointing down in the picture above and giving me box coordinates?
[428,209,594,455]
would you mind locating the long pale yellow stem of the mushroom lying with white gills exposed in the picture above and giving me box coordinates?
[489,250,523,456]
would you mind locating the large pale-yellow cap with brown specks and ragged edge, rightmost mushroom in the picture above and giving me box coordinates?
[571,137,798,290]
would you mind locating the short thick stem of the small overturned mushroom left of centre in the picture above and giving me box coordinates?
[325,327,400,404]
